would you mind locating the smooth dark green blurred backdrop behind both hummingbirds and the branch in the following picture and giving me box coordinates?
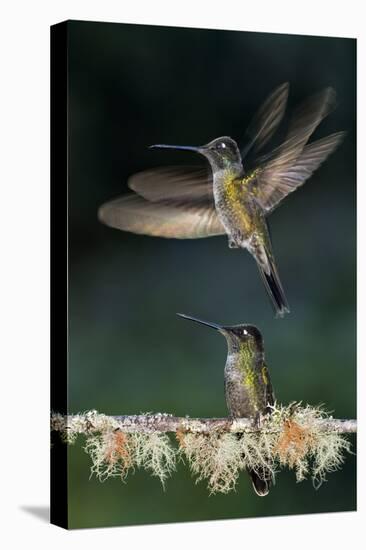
[64,21,356,527]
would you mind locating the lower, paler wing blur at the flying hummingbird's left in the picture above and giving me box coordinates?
[98,194,225,239]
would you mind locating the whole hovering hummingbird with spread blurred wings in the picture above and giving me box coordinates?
[99,83,344,317]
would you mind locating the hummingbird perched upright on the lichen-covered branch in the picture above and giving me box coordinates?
[178,313,275,496]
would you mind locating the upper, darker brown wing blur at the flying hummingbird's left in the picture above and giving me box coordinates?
[128,166,213,202]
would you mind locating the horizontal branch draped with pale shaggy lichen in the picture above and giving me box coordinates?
[51,403,357,493]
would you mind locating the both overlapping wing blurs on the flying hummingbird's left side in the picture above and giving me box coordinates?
[98,166,225,239]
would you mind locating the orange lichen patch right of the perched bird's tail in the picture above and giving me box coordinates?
[275,420,313,468]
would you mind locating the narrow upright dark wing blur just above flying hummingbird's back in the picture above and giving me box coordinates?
[242,82,289,158]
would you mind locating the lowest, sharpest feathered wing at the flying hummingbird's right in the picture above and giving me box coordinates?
[255,132,345,212]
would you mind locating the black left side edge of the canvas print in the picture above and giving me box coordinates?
[50,22,68,529]
